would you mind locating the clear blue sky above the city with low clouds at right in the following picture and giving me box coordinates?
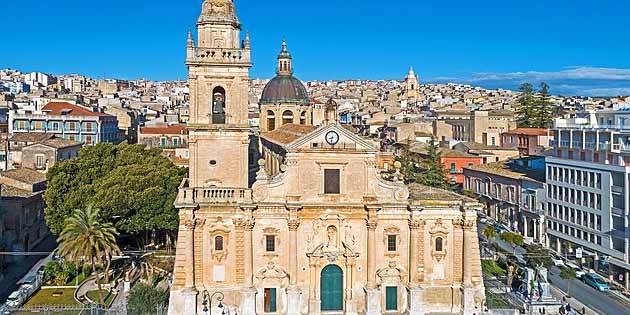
[0,0,630,95]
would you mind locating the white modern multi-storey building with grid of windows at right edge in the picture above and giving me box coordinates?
[546,107,630,288]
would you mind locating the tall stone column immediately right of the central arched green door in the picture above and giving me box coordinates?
[366,207,381,315]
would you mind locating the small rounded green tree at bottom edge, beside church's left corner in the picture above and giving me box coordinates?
[127,283,168,315]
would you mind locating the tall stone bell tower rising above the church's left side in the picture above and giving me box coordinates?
[186,0,252,187]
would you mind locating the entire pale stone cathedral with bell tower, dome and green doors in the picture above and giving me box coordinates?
[169,0,485,315]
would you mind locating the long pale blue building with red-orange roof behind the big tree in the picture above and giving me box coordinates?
[9,102,121,145]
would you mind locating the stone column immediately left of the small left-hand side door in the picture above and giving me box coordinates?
[241,206,256,314]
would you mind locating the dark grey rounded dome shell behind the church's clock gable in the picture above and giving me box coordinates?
[260,75,309,104]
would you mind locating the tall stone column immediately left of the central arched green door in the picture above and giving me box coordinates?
[287,206,300,315]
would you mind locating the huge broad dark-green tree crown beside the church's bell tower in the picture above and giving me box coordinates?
[45,144,186,234]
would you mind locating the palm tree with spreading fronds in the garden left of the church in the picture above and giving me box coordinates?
[57,207,121,304]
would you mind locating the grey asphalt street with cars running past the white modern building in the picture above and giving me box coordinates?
[478,223,630,315]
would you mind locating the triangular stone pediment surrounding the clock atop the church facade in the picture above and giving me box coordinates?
[286,124,378,152]
